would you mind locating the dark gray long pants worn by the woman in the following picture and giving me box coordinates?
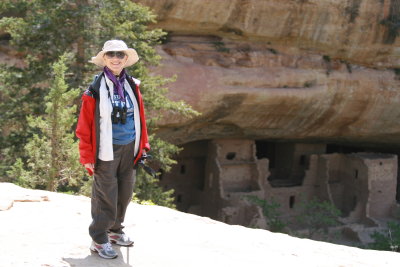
[89,142,136,244]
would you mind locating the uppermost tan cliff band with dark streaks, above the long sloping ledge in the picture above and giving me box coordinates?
[138,0,400,67]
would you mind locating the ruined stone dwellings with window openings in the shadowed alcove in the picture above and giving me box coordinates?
[160,139,398,244]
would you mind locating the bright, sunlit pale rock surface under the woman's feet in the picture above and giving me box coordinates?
[0,183,400,267]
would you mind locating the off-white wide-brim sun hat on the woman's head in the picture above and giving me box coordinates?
[89,40,139,67]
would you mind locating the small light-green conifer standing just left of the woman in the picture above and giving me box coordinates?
[9,56,84,191]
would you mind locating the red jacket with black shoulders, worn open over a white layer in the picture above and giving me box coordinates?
[76,73,150,175]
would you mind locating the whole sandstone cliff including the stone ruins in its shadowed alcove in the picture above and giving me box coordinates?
[138,0,400,241]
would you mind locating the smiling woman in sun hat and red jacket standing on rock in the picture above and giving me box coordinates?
[76,40,150,259]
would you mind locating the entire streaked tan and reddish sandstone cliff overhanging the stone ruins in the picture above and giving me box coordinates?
[137,0,400,146]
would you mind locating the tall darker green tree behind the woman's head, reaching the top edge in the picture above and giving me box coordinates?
[0,0,196,205]
